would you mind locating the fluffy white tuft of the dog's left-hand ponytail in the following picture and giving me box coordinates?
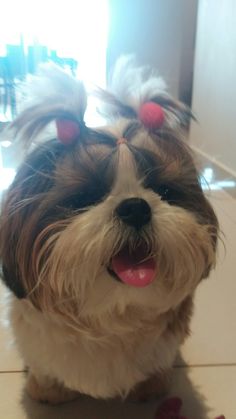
[9,64,87,146]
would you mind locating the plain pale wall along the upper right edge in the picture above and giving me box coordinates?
[190,0,236,175]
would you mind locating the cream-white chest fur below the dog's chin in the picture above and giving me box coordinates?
[11,298,178,398]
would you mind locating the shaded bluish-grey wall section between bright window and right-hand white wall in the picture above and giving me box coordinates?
[107,0,197,102]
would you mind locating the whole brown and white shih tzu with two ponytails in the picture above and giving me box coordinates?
[0,55,218,403]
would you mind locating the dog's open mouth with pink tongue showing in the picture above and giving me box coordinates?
[112,246,156,287]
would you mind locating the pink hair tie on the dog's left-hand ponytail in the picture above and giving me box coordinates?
[56,118,80,145]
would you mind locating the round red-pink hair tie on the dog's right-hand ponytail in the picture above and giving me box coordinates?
[138,102,165,130]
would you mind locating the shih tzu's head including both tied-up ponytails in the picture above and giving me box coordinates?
[0,55,217,324]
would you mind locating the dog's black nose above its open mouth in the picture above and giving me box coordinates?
[116,198,151,228]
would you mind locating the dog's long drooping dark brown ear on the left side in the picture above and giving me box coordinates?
[0,140,67,298]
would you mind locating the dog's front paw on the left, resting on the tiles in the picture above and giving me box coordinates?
[26,374,79,405]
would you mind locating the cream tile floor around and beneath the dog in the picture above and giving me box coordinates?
[0,191,236,419]
